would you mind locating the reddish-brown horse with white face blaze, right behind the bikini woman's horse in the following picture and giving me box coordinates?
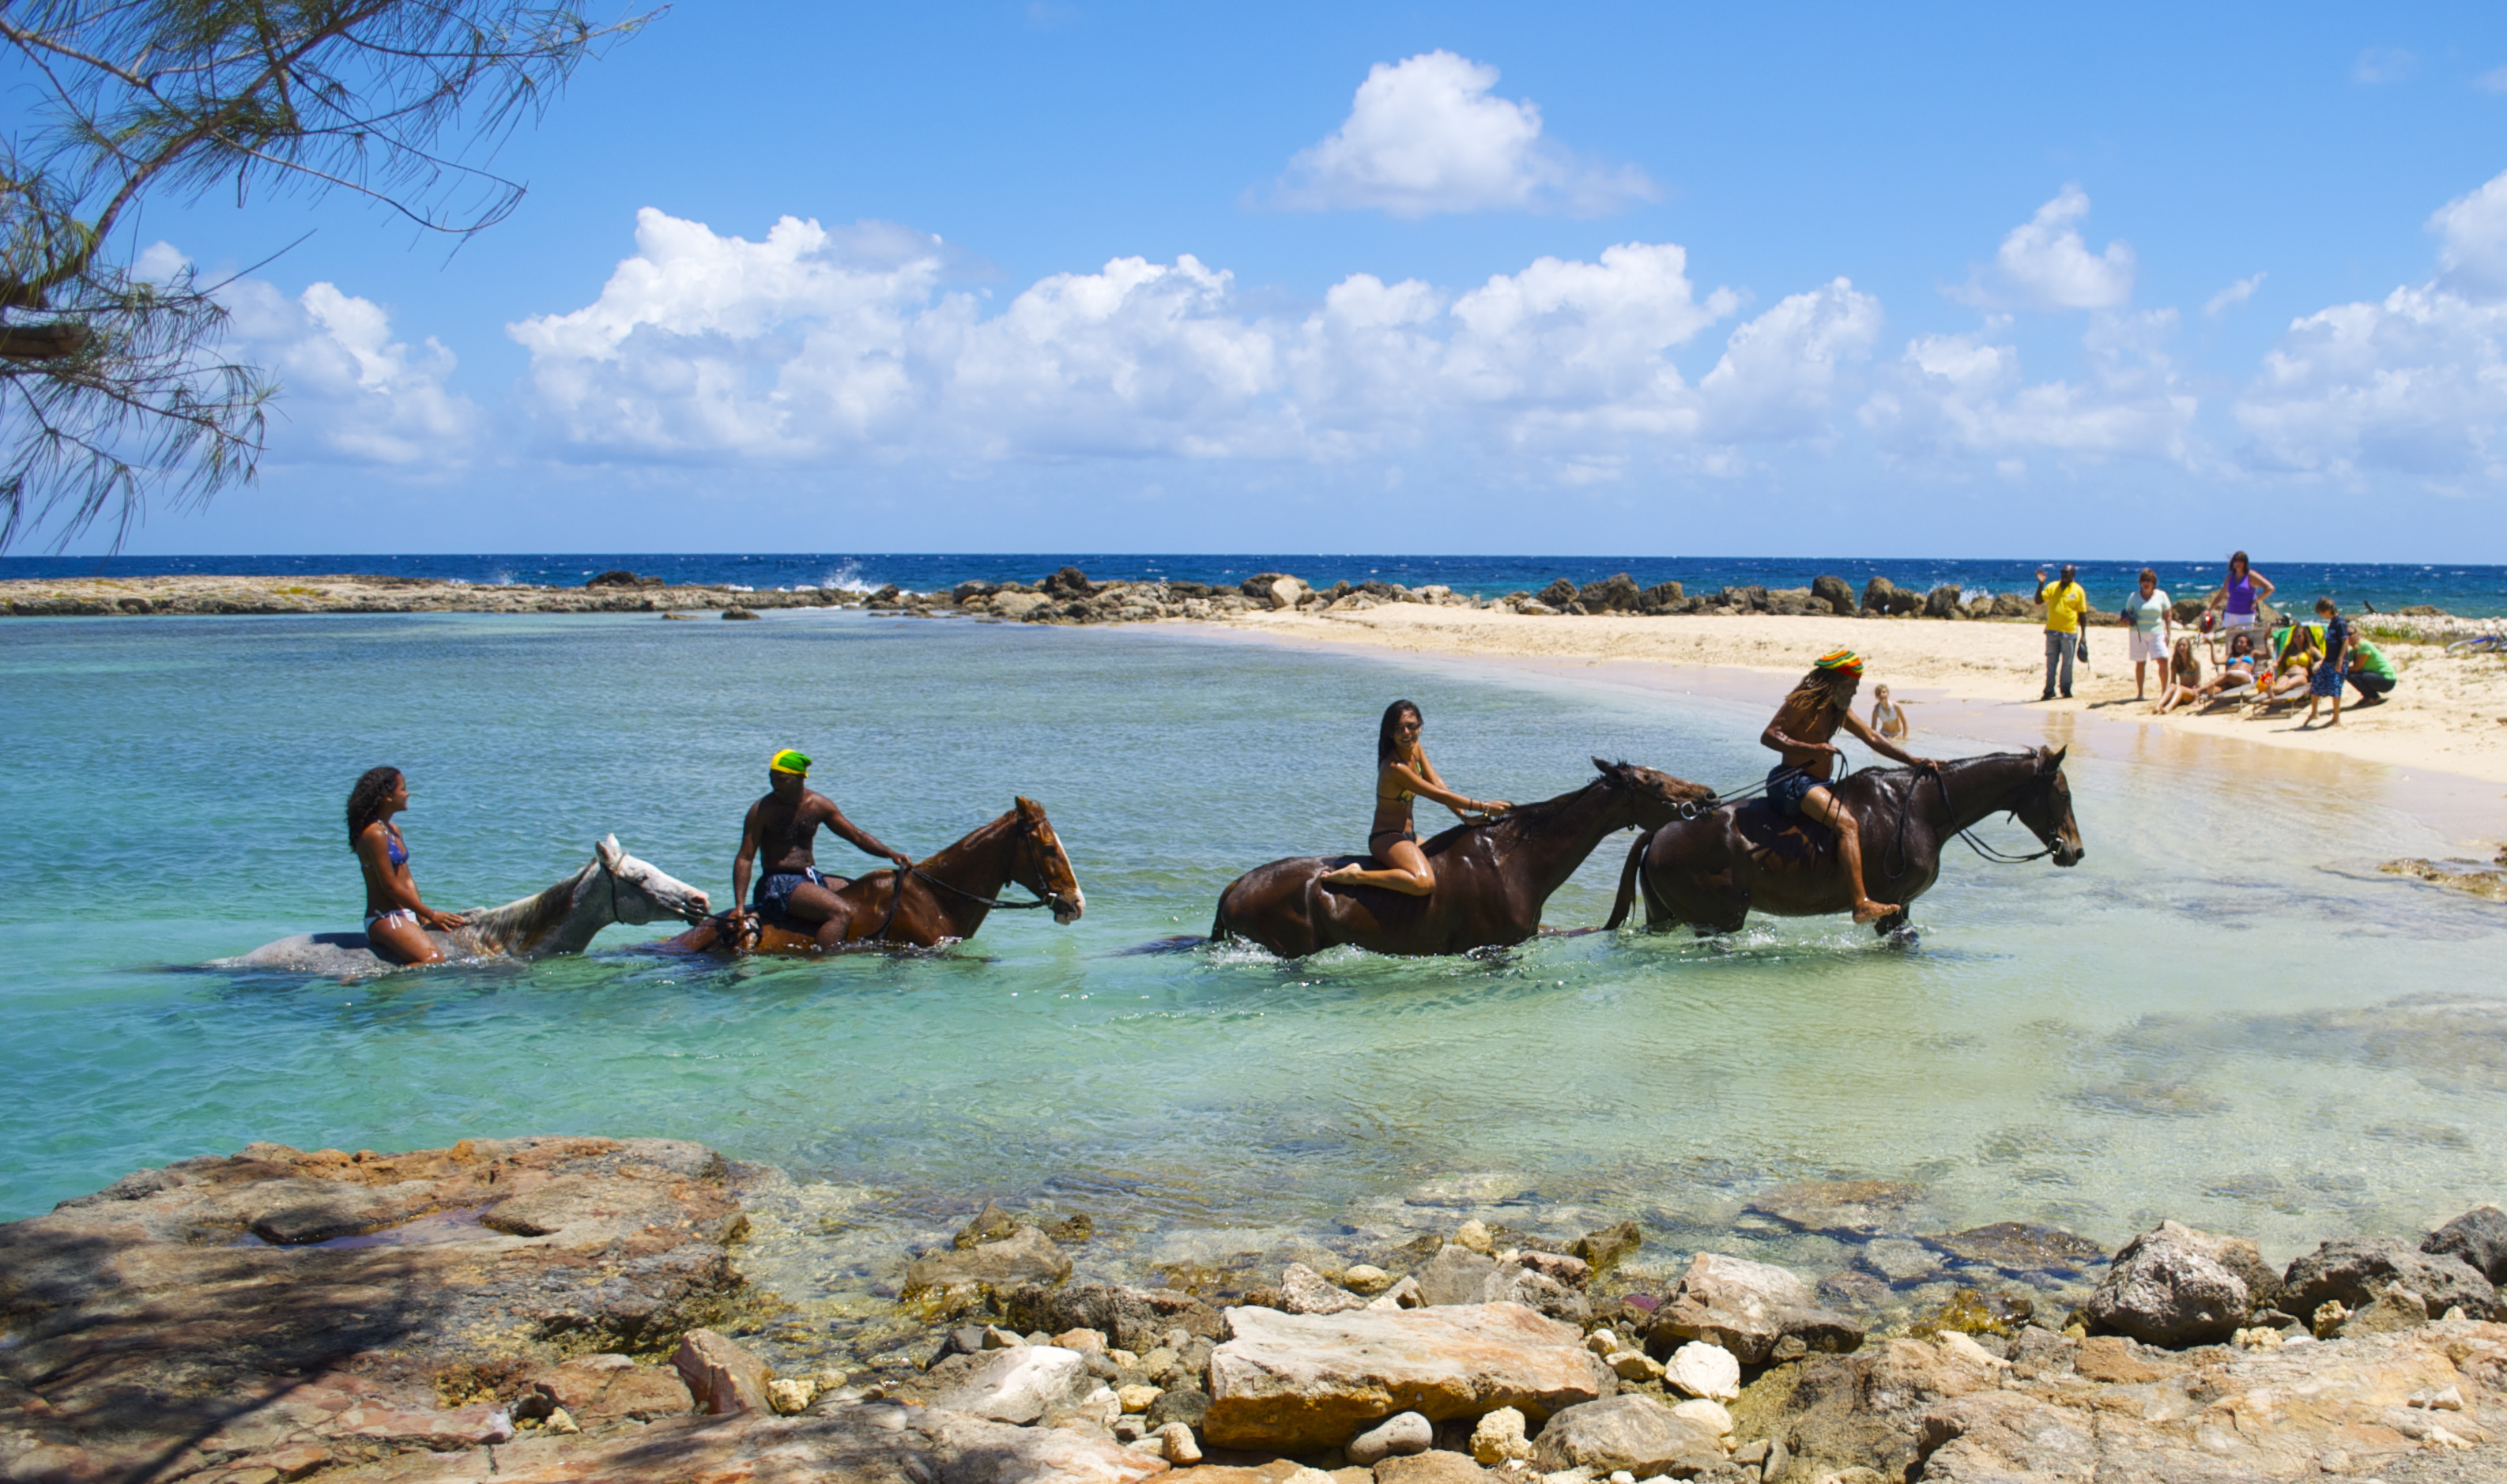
[662,800,1088,952]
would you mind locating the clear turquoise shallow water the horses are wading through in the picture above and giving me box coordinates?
[0,601,2507,1333]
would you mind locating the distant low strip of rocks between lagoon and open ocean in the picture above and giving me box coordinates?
[0,567,2502,637]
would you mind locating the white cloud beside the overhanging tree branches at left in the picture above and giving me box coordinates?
[221,275,479,464]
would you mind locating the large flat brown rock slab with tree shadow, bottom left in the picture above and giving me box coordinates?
[0,1138,747,1479]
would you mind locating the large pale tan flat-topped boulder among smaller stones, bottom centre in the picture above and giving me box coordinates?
[1204,1304,1617,1452]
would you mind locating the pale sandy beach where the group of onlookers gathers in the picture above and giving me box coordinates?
[1228,605,2507,785]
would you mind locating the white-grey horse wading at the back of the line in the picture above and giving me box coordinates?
[205,834,712,975]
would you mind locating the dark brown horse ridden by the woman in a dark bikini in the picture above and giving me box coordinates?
[1211,757,1715,958]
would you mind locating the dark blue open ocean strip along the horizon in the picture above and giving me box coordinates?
[0,552,2507,620]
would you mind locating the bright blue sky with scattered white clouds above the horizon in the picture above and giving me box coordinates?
[13,0,2507,562]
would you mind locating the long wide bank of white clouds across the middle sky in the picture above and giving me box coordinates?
[509,210,1880,479]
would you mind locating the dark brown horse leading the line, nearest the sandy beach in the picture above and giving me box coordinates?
[1609,747,2086,937]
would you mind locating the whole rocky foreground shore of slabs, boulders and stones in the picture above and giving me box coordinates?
[0,1138,2507,1484]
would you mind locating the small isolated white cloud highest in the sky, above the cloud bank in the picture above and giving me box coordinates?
[1273,50,1662,218]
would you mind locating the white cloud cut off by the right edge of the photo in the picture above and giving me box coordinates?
[2236,173,2507,489]
